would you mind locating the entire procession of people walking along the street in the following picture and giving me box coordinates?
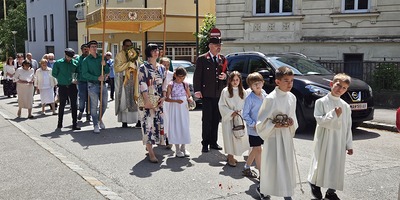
[2,37,353,200]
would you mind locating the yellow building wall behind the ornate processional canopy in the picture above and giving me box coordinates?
[78,0,215,61]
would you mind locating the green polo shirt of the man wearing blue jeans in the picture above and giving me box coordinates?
[81,54,110,83]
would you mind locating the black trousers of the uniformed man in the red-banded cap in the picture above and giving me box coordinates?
[201,97,221,146]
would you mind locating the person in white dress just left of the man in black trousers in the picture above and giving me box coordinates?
[35,59,57,115]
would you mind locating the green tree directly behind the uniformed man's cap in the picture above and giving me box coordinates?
[197,13,216,54]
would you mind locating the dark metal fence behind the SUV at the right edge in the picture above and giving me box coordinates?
[318,60,400,90]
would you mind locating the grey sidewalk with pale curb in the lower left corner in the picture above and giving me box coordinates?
[0,109,106,200]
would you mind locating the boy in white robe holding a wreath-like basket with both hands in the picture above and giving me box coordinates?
[256,67,298,200]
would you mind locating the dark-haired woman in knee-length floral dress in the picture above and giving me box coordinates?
[138,44,165,163]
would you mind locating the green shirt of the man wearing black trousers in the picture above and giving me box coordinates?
[51,58,78,85]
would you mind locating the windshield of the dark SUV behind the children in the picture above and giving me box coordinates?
[271,56,332,75]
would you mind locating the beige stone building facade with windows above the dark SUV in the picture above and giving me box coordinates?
[216,0,400,62]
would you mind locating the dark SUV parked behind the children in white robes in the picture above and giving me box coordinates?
[226,52,374,130]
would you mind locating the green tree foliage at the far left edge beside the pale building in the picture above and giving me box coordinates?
[0,0,27,60]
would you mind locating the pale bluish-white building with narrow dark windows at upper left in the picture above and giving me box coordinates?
[25,0,81,60]
